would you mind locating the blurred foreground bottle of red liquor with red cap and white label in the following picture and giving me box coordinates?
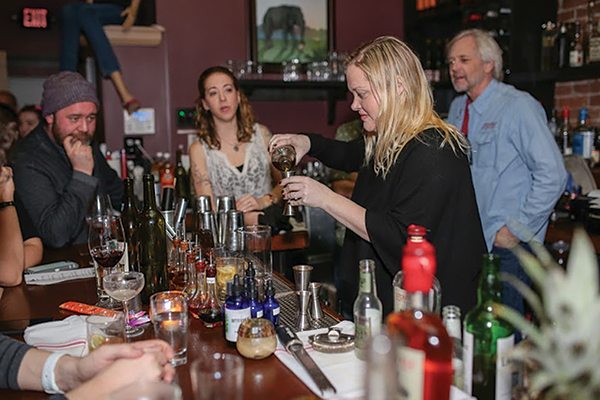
[386,233,453,400]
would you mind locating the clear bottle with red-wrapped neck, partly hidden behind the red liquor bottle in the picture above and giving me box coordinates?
[392,225,442,315]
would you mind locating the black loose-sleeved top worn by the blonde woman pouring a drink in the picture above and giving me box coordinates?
[309,129,486,315]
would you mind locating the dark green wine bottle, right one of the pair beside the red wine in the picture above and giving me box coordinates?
[138,175,169,304]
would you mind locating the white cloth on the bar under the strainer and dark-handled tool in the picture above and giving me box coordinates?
[275,321,476,400]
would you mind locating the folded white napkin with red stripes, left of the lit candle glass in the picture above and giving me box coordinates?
[23,315,88,357]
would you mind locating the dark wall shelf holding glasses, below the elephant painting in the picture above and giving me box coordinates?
[240,79,348,125]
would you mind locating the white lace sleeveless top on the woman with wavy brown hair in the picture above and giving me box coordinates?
[200,124,273,199]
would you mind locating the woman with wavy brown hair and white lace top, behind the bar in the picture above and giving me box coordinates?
[190,67,281,224]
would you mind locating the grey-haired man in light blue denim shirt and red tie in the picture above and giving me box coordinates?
[448,29,567,320]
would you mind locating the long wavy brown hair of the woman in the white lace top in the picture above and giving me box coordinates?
[196,66,254,149]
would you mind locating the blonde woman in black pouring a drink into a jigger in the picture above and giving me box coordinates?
[270,36,485,316]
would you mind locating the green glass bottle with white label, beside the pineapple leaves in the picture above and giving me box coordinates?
[463,254,514,400]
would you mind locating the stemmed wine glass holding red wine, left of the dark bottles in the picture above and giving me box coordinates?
[88,215,125,309]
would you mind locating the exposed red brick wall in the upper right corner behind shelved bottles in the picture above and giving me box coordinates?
[554,0,600,126]
